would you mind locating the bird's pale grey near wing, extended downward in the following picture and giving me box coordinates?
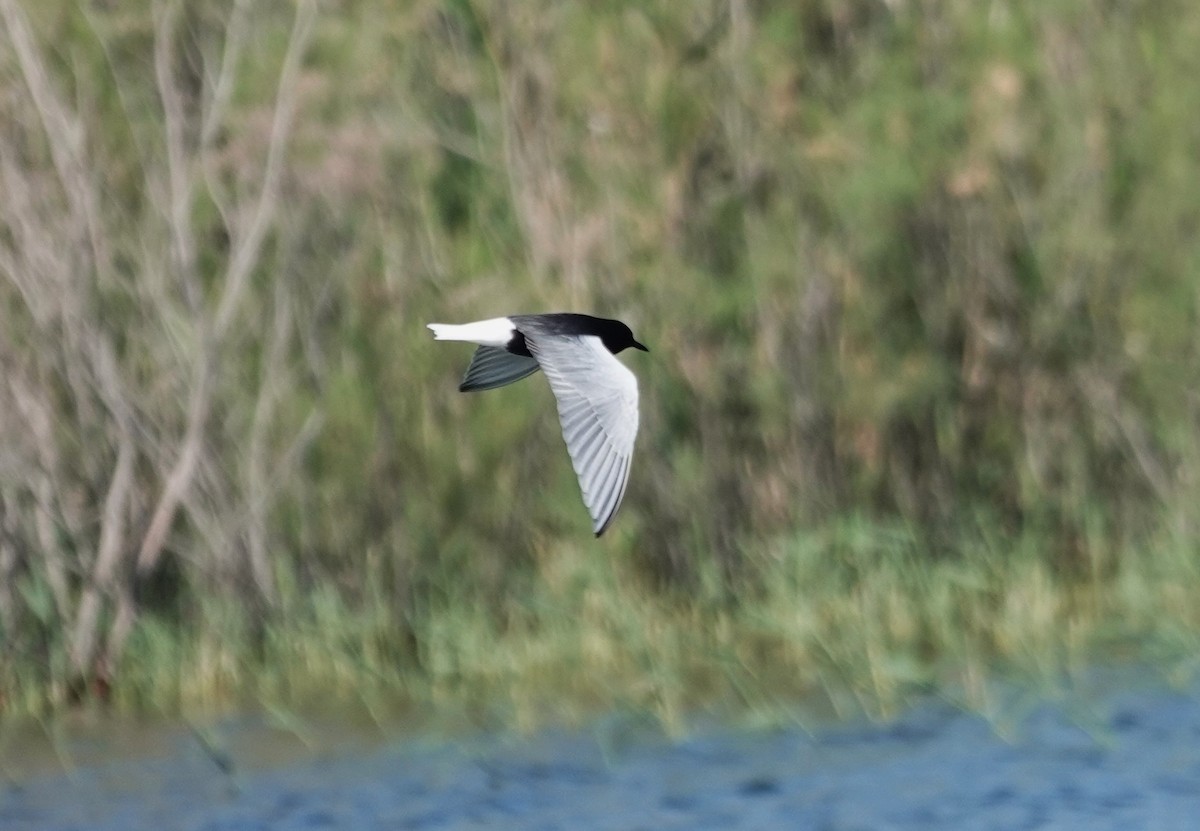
[526,331,637,537]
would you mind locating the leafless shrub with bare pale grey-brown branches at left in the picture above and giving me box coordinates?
[0,0,319,688]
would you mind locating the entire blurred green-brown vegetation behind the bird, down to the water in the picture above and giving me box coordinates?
[0,0,1200,723]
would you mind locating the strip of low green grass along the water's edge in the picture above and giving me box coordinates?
[10,519,1200,729]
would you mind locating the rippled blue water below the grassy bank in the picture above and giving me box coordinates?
[0,687,1200,831]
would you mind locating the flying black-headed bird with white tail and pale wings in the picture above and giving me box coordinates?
[428,312,649,537]
